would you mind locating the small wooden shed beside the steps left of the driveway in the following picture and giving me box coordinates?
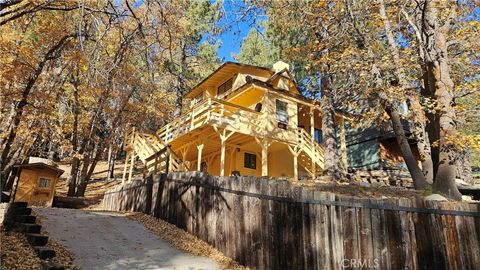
[13,162,63,206]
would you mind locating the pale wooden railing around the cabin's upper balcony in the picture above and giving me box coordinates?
[157,98,265,144]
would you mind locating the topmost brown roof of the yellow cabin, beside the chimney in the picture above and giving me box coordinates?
[185,62,275,98]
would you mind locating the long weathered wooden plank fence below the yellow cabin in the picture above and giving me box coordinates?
[104,172,480,269]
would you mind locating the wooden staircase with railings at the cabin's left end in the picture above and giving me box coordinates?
[123,128,180,181]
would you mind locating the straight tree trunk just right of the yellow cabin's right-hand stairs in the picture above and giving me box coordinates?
[320,76,342,179]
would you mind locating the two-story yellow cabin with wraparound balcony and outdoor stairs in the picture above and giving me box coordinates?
[124,61,347,182]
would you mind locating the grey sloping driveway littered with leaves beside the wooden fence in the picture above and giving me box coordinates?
[34,208,218,270]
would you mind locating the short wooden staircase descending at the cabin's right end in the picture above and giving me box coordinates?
[297,128,324,177]
